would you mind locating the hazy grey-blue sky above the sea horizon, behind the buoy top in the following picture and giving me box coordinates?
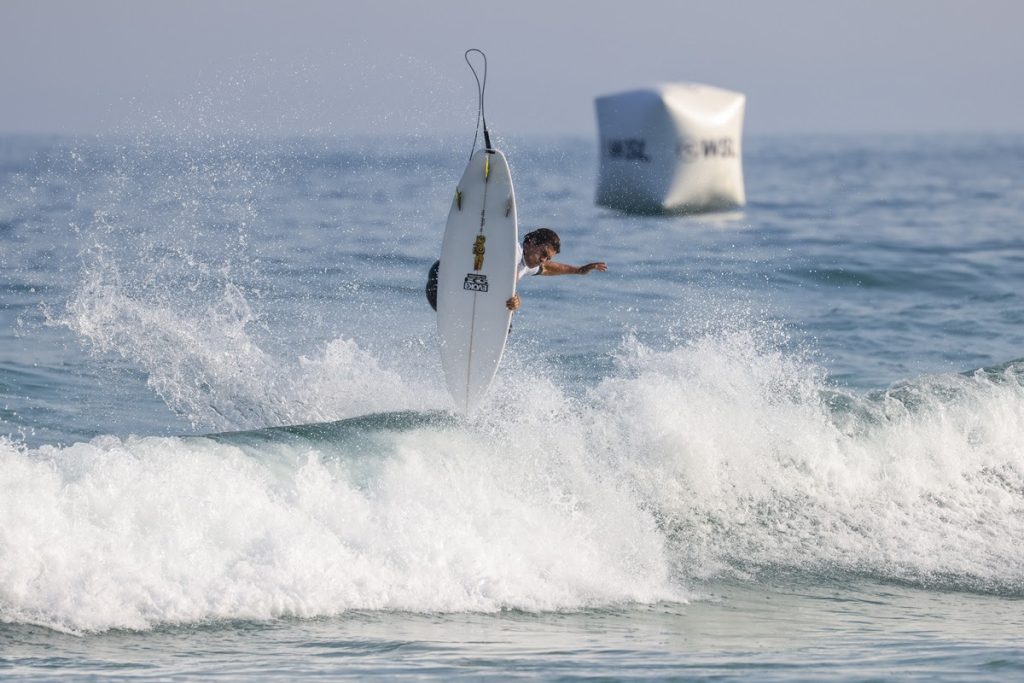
[0,0,1024,135]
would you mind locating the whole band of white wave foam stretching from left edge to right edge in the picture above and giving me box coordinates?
[0,323,1024,630]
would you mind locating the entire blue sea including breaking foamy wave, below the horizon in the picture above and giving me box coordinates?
[0,126,1024,680]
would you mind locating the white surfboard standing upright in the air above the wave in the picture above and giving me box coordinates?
[437,150,519,413]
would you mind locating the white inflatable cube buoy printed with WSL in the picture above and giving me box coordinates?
[595,83,746,213]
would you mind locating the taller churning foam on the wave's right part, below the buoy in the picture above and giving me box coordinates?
[590,333,1024,592]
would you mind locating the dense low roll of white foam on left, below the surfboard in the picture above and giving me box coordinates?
[0,421,680,630]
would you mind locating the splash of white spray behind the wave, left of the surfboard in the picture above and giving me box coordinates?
[59,254,444,430]
